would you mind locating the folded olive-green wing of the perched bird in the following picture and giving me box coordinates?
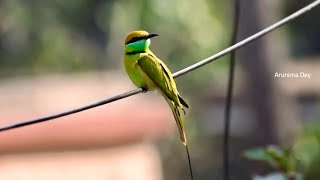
[138,54,178,103]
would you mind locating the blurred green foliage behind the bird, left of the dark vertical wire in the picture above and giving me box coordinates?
[0,0,232,90]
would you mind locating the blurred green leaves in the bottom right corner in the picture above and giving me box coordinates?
[244,121,320,180]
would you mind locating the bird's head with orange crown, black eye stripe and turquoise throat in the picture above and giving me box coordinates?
[125,31,158,53]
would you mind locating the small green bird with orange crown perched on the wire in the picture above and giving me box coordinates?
[124,31,189,146]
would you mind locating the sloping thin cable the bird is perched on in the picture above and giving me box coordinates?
[0,0,320,131]
